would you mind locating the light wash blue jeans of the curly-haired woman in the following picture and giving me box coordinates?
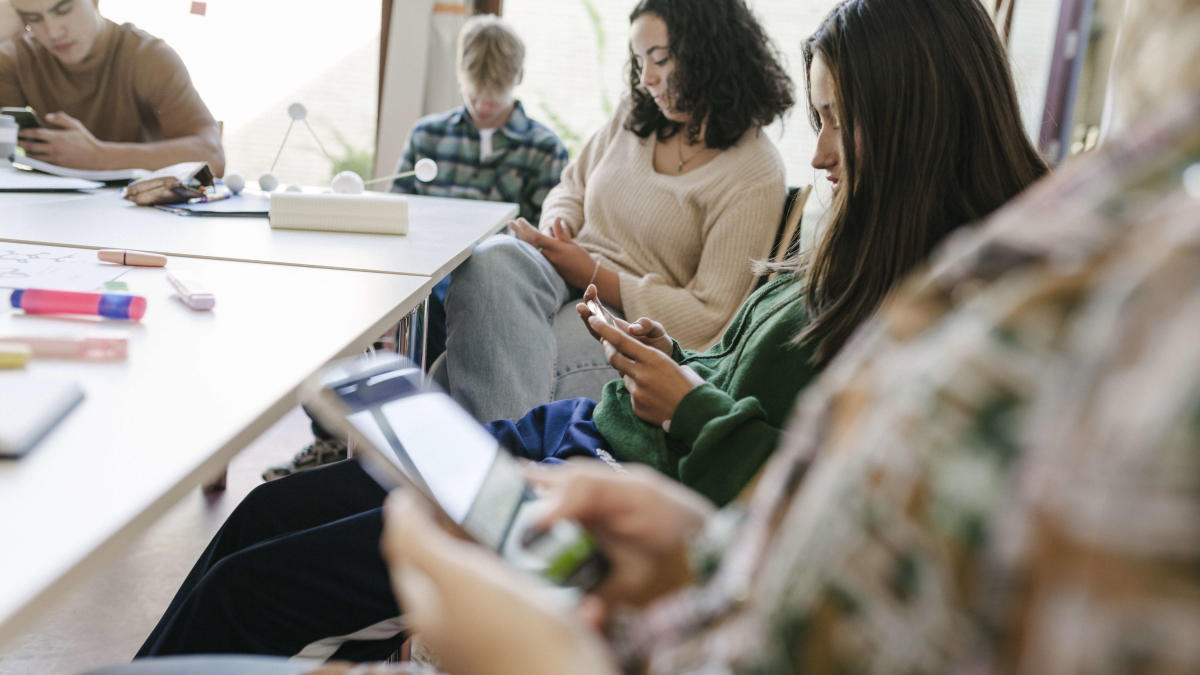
[445,234,618,422]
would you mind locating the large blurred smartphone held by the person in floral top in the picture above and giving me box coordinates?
[301,354,608,590]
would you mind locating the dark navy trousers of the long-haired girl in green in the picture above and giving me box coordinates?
[137,399,611,661]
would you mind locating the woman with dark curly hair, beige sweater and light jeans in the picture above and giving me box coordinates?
[445,0,793,422]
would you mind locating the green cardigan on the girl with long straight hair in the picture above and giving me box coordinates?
[593,275,820,504]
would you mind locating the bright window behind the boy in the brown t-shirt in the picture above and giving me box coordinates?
[100,0,379,185]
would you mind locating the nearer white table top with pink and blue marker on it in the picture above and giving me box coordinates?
[0,240,434,641]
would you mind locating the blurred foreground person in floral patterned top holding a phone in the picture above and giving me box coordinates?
[362,0,1200,675]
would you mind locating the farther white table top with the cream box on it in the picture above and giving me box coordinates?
[0,190,517,279]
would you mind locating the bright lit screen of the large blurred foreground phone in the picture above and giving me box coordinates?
[334,370,528,549]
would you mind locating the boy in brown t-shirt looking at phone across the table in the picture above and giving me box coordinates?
[0,0,224,175]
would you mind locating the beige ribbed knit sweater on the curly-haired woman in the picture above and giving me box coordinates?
[540,103,786,350]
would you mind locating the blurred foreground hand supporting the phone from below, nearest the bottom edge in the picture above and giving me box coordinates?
[382,492,616,675]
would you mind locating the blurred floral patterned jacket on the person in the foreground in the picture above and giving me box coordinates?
[616,96,1200,673]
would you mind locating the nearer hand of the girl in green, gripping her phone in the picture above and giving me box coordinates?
[587,316,704,425]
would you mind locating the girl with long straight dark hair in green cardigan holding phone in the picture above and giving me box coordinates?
[139,0,1045,661]
